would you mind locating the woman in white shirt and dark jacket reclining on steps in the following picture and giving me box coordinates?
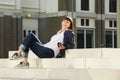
[10,16,74,68]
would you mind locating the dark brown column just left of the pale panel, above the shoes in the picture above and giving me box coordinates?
[12,13,22,50]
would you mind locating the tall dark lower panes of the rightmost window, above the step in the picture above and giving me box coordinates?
[106,31,117,48]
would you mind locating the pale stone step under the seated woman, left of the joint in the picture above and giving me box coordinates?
[0,58,85,68]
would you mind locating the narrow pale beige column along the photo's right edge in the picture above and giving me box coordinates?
[117,0,120,48]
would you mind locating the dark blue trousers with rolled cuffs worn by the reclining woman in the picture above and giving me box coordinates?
[19,33,54,58]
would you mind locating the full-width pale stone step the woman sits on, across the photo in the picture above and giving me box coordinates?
[0,58,120,69]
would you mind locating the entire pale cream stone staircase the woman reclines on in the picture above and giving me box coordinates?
[0,48,120,80]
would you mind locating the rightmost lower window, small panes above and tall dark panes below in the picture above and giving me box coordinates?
[105,20,117,48]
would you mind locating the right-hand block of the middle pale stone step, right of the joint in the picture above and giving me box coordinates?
[85,58,120,69]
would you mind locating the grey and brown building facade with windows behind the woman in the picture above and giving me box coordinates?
[0,0,118,58]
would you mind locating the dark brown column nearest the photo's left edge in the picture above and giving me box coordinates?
[2,15,13,58]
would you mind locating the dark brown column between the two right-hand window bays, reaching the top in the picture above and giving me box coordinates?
[95,0,105,47]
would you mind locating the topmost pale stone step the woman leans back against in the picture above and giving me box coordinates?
[65,48,120,58]
